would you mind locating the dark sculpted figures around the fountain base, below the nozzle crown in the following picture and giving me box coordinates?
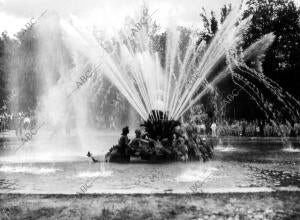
[105,125,213,162]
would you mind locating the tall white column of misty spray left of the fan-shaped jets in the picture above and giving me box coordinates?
[4,12,116,162]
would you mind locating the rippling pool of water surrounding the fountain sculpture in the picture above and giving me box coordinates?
[0,134,300,194]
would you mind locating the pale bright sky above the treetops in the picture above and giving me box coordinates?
[0,0,239,36]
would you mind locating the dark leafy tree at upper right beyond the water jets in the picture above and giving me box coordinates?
[244,0,300,98]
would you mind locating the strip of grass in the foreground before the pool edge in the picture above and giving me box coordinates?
[0,192,300,220]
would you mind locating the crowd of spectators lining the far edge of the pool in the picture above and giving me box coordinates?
[0,103,300,137]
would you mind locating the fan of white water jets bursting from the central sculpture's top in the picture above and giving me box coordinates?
[91,1,299,125]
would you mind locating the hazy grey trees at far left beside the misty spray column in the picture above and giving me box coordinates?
[1,16,71,111]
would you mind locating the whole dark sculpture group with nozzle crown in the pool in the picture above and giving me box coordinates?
[105,110,213,162]
